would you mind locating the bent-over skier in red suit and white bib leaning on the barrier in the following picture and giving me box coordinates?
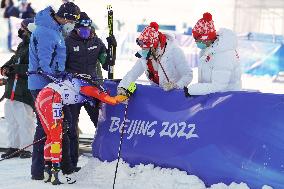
[35,73,126,185]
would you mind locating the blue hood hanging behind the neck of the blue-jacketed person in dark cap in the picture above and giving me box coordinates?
[35,7,61,31]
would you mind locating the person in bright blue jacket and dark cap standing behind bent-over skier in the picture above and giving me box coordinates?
[28,3,80,180]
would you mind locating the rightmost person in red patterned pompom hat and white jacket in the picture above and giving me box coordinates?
[188,13,241,95]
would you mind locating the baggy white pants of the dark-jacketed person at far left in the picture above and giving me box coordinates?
[4,99,36,150]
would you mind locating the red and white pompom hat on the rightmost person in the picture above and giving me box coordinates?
[192,12,216,41]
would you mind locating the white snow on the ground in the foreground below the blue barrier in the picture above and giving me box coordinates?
[0,156,272,189]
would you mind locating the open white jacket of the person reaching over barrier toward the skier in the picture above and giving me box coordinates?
[118,34,192,89]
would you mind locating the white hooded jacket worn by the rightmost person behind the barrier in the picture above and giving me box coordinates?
[188,29,241,95]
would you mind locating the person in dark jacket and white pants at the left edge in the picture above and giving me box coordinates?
[1,18,35,158]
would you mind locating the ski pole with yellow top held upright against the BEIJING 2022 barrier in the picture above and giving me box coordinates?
[112,82,136,189]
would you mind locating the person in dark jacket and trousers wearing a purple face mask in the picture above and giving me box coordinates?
[65,12,116,166]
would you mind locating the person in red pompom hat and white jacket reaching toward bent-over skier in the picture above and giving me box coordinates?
[117,22,192,95]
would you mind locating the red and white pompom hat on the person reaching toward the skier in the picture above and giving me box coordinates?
[136,22,162,48]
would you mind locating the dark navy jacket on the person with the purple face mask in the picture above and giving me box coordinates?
[65,30,107,77]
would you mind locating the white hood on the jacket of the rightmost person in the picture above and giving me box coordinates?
[212,28,238,52]
